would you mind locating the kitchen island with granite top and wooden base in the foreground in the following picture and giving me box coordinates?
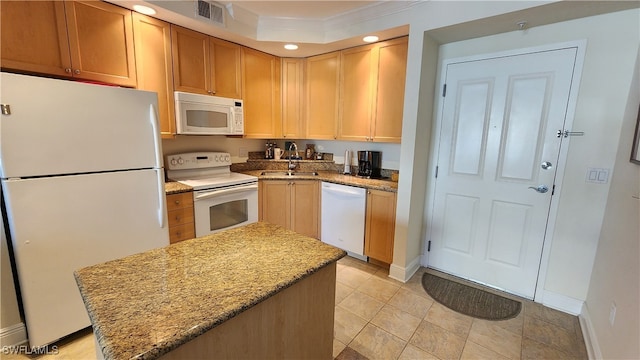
[75,222,345,359]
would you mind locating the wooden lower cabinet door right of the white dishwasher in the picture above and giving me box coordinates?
[364,190,396,264]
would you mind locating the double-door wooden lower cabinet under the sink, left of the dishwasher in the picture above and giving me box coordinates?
[259,180,320,239]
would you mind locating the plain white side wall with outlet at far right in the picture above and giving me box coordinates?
[583,48,640,359]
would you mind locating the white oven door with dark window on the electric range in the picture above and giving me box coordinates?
[193,183,258,237]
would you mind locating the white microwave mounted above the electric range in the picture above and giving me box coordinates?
[175,91,244,135]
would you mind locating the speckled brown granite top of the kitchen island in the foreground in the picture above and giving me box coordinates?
[75,222,346,359]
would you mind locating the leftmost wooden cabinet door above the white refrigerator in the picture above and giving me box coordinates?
[0,1,71,76]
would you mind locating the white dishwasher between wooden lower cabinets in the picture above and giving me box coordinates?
[320,182,367,260]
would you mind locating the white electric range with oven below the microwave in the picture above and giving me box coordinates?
[166,152,258,236]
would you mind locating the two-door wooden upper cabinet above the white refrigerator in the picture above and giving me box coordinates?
[1,1,136,87]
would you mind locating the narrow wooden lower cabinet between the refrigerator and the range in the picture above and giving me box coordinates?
[167,192,196,244]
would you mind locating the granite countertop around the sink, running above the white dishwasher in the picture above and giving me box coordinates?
[242,170,398,192]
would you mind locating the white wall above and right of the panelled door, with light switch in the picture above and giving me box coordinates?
[422,10,640,304]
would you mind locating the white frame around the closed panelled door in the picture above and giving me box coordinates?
[421,39,587,303]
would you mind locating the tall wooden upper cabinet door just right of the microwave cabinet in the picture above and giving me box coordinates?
[242,47,282,139]
